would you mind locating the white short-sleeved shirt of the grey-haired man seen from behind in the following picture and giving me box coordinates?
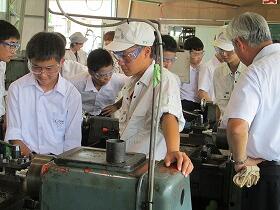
[224,44,280,161]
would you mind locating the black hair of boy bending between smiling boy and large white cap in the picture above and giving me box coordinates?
[87,48,113,72]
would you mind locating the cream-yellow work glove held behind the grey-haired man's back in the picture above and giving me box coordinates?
[233,166,260,188]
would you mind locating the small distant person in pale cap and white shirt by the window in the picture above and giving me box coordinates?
[65,32,87,66]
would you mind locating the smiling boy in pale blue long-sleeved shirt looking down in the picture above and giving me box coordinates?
[5,32,82,155]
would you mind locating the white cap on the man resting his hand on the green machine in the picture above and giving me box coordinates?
[105,22,155,51]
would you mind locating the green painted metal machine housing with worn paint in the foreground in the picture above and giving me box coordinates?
[40,150,192,210]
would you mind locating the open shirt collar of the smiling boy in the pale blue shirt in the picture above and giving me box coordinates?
[23,73,66,96]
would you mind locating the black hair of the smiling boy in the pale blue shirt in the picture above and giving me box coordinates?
[26,32,65,62]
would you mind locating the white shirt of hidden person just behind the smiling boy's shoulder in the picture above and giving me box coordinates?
[61,60,88,80]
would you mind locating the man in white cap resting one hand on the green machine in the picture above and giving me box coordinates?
[106,22,193,176]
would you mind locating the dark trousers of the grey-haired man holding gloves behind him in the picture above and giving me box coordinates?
[242,161,280,210]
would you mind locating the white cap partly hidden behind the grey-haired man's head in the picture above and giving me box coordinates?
[213,26,234,51]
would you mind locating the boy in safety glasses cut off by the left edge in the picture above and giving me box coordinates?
[0,20,20,140]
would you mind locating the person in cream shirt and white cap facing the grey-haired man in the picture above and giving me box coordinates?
[213,27,246,120]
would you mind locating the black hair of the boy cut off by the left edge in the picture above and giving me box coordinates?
[0,20,20,41]
